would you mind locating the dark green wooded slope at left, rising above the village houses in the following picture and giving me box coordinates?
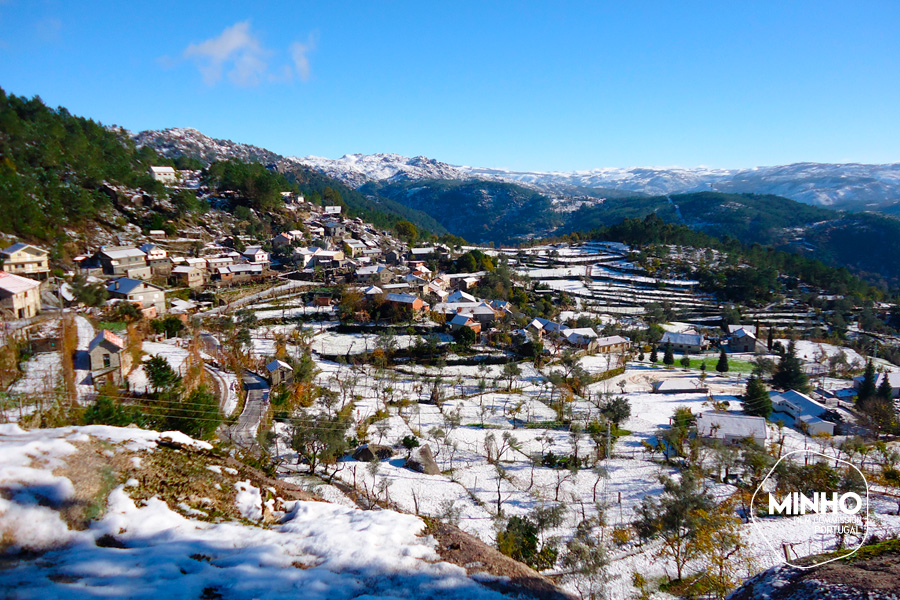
[0,89,447,251]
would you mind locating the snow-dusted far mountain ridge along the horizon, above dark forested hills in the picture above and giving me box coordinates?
[134,129,900,210]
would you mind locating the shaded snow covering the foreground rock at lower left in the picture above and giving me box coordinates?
[0,425,505,600]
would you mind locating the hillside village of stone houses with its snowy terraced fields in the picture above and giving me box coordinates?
[0,159,900,598]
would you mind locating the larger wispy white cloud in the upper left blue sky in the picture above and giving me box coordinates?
[181,20,315,87]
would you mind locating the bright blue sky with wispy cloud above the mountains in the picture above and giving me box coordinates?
[0,0,900,170]
